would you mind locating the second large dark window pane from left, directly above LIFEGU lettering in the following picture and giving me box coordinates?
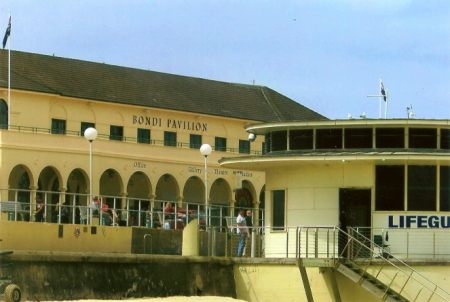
[408,166,436,211]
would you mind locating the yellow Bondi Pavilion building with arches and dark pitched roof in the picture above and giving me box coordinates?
[0,51,324,225]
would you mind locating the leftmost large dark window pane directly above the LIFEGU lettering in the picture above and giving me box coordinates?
[375,166,405,211]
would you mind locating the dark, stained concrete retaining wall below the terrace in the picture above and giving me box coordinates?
[5,252,236,301]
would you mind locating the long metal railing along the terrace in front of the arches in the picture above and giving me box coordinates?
[0,188,264,230]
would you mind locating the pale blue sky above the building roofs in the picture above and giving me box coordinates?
[0,0,450,119]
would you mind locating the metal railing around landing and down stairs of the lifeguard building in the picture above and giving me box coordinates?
[297,226,450,301]
